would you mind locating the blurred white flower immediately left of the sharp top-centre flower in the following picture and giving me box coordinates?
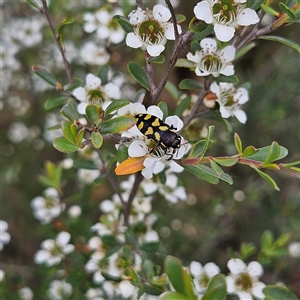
[83,8,125,44]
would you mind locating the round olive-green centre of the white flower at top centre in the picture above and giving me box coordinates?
[138,20,164,45]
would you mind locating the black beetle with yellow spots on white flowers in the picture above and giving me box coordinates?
[134,114,181,160]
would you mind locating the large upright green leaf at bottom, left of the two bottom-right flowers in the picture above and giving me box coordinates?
[165,255,196,300]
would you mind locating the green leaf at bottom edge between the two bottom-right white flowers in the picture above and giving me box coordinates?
[202,274,227,300]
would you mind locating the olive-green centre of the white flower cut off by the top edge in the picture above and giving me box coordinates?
[212,0,237,24]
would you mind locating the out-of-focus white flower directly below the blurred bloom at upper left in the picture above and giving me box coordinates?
[80,42,110,66]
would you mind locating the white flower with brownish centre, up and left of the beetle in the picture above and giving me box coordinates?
[73,74,120,114]
